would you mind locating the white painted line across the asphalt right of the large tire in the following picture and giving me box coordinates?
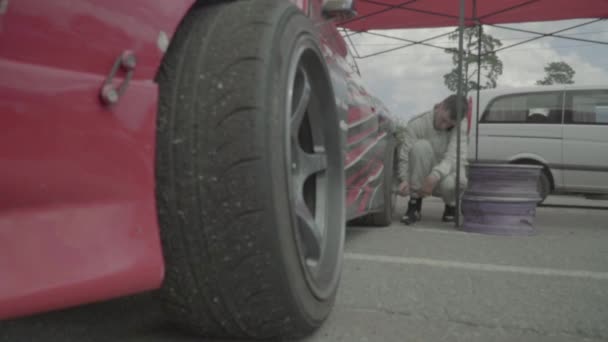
[344,253,608,280]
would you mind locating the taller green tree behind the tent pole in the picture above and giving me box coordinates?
[443,27,502,94]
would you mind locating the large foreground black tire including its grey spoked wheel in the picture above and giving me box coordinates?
[156,0,345,338]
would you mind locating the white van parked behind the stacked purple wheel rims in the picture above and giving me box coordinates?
[468,85,608,198]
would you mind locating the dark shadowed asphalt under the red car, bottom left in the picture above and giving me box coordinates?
[0,292,254,342]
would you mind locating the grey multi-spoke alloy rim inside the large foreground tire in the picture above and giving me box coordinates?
[286,40,344,299]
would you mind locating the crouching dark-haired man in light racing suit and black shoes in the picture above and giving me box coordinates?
[397,95,467,225]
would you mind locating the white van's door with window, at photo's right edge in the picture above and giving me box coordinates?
[562,89,608,193]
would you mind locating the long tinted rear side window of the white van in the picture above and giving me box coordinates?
[481,92,562,124]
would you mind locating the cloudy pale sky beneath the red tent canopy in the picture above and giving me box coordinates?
[352,19,608,119]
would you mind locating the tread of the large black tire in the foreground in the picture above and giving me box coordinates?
[157,0,309,338]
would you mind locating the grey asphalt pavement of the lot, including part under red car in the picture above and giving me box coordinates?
[0,197,608,342]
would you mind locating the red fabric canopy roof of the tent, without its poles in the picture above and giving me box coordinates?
[340,0,608,31]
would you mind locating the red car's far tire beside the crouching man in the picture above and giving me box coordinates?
[353,139,397,227]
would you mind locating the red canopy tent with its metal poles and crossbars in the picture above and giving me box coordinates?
[339,0,608,227]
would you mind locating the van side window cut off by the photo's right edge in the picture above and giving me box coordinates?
[565,90,608,125]
